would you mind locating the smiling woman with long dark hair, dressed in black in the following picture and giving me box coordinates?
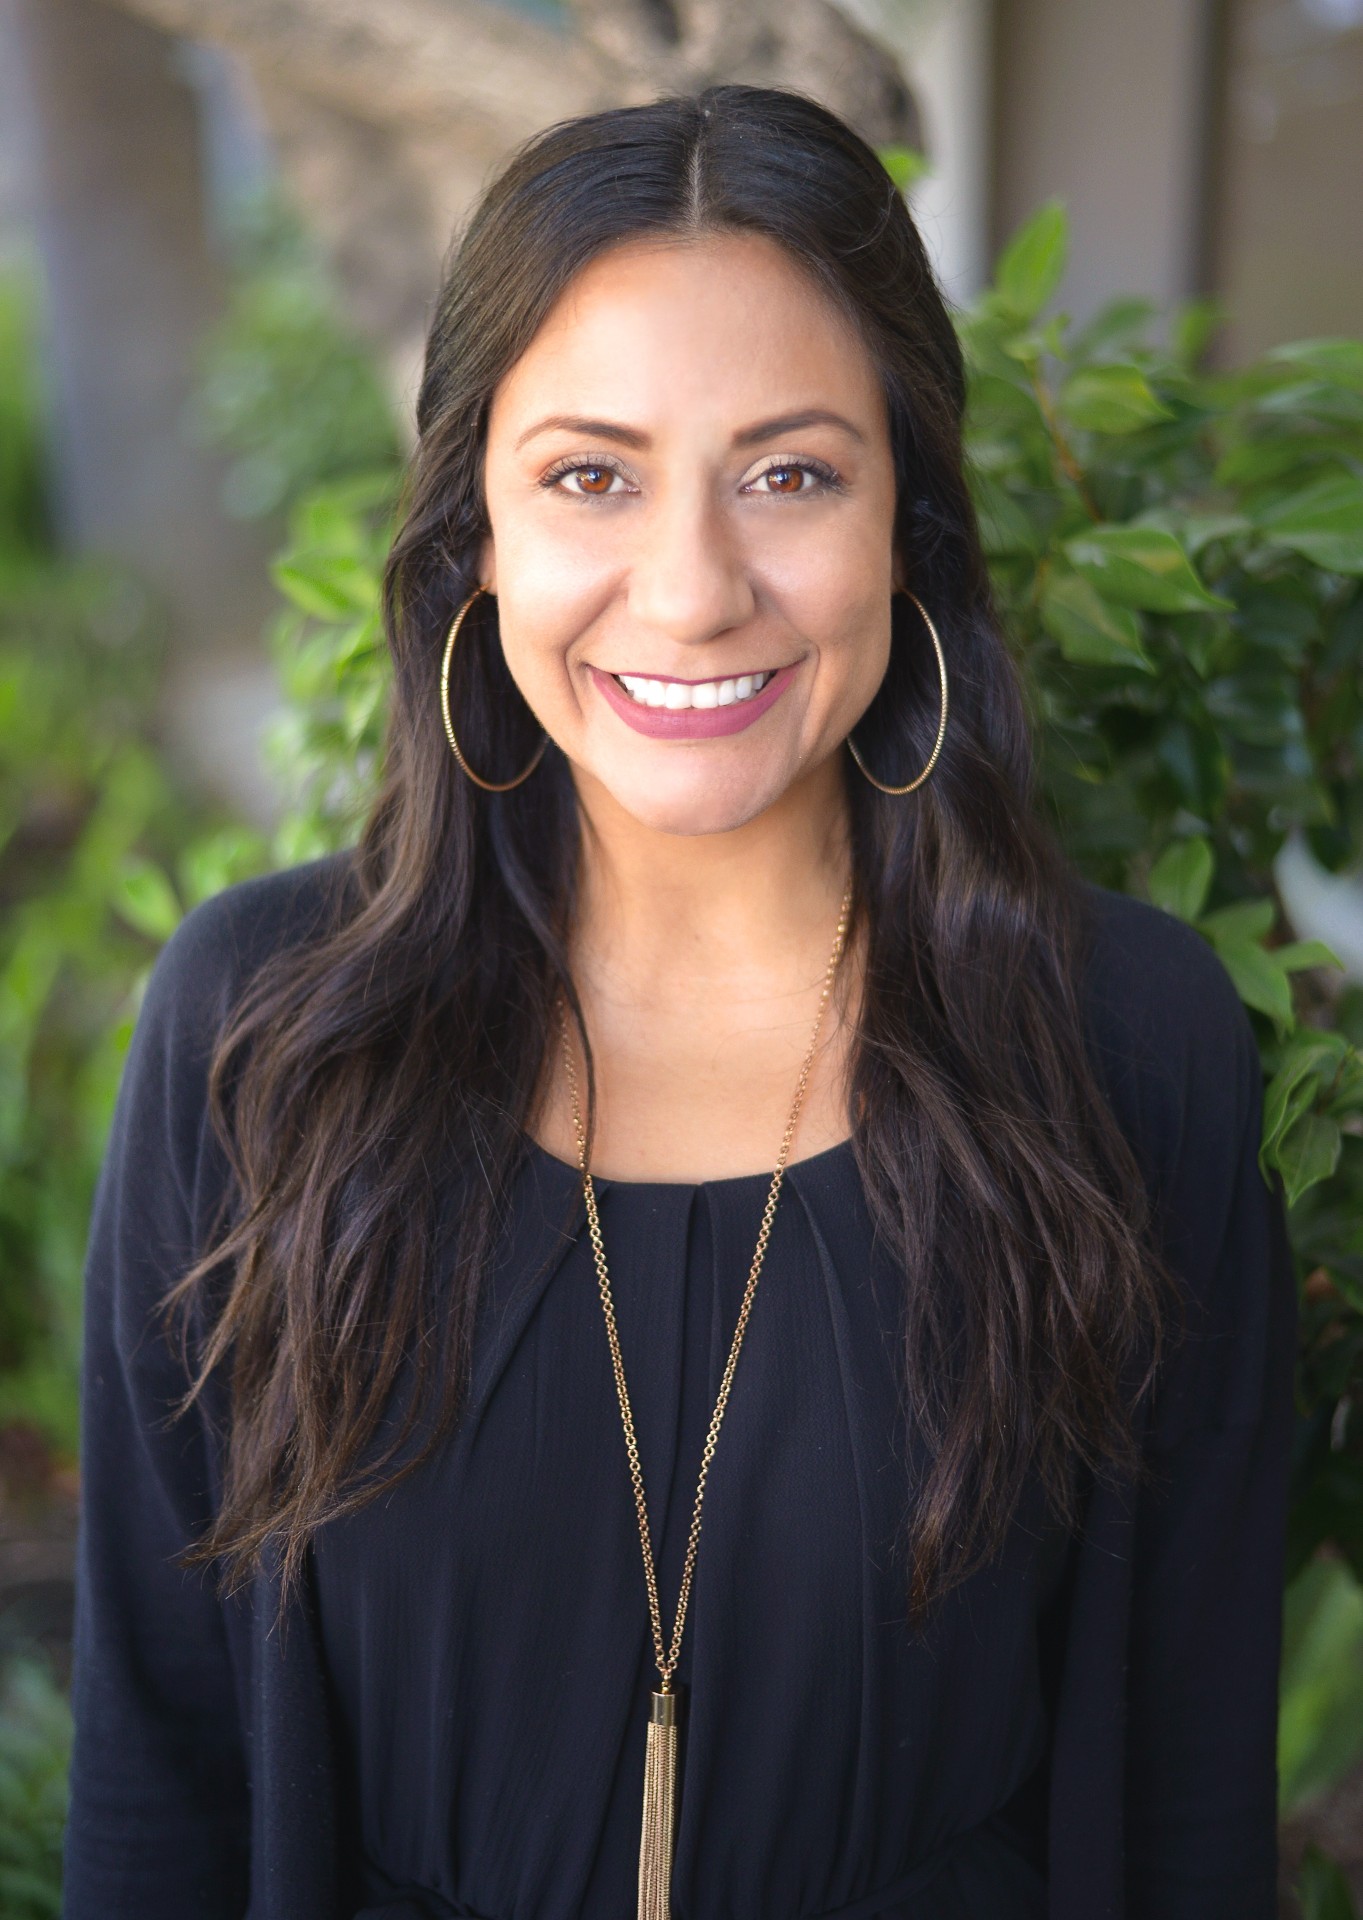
[67,86,1294,1920]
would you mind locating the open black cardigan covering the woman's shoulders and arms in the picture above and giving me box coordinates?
[65,858,1296,1920]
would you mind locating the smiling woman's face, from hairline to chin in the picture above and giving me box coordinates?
[482,234,900,833]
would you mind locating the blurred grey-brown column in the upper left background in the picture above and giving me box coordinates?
[12,0,275,812]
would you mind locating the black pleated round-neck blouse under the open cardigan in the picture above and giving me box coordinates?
[317,1146,1064,1920]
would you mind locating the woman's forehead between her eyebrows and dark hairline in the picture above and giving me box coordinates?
[490,234,883,434]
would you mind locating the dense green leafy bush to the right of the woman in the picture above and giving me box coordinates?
[962,205,1363,1605]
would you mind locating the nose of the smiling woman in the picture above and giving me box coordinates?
[628,486,756,647]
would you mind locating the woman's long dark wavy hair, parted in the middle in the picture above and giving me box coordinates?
[173,86,1167,1615]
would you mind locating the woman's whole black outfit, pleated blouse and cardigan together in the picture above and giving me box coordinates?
[65,860,1296,1920]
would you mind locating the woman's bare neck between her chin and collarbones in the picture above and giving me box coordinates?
[574,755,850,1002]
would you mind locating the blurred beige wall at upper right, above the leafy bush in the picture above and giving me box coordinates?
[991,0,1363,361]
